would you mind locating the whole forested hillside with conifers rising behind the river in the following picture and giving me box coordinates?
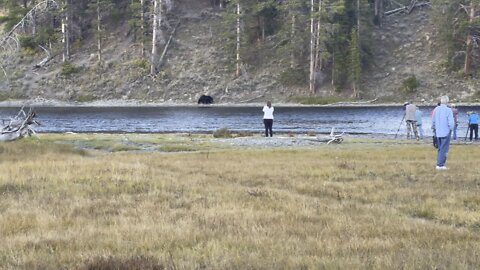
[0,0,480,103]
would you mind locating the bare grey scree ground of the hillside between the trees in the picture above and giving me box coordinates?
[0,0,477,103]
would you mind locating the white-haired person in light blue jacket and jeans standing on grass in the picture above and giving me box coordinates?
[432,96,455,170]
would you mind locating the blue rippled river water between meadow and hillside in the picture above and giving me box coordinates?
[0,106,480,137]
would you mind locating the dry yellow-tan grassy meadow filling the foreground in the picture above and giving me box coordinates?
[0,134,480,269]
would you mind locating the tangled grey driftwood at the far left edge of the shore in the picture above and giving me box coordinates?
[0,107,40,141]
